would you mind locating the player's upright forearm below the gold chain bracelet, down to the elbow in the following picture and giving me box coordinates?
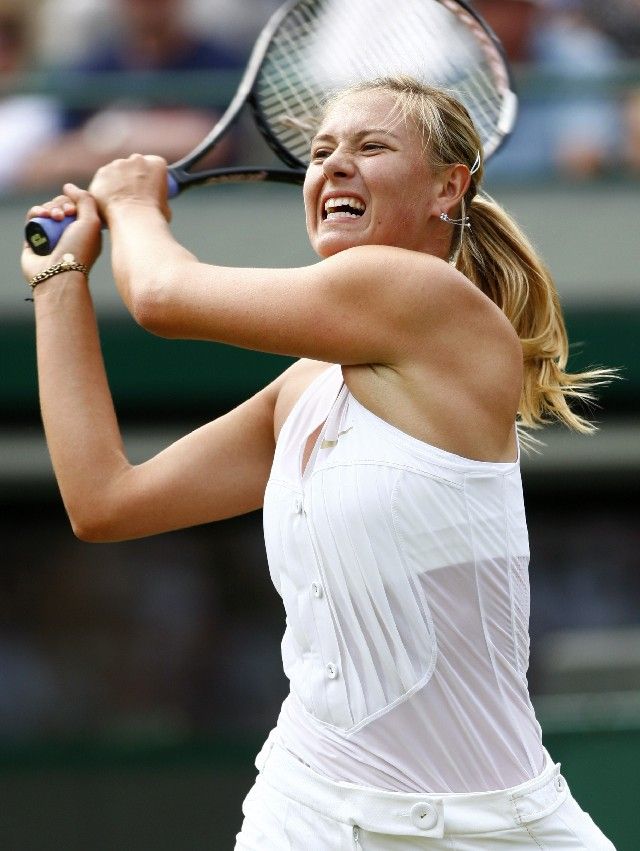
[34,272,129,538]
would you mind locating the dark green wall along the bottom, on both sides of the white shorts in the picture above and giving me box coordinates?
[0,728,640,851]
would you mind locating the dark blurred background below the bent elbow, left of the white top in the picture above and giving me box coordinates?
[0,507,286,750]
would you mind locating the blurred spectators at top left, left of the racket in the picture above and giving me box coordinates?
[0,0,277,191]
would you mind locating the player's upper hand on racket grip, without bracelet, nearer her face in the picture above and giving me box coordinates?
[89,154,171,224]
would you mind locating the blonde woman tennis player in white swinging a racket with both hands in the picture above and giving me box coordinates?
[23,79,613,851]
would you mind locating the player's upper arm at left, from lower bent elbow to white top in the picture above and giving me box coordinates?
[79,376,282,541]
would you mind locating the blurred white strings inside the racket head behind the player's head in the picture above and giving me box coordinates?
[255,0,509,165]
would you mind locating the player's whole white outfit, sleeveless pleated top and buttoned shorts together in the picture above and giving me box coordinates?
[235,366,615,851]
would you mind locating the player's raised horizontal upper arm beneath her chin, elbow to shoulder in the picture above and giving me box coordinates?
[137,246,461,364]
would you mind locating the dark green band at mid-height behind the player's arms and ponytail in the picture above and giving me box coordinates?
[0,307,640,418]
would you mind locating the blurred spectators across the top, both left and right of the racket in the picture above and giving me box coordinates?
[0,0,640,193]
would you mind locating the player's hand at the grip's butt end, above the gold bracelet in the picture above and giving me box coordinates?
[22,183,102,281]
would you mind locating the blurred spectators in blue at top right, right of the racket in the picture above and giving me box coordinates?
[473,0,640,179]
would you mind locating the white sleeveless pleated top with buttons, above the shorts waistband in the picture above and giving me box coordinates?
[264,365,544,792]
